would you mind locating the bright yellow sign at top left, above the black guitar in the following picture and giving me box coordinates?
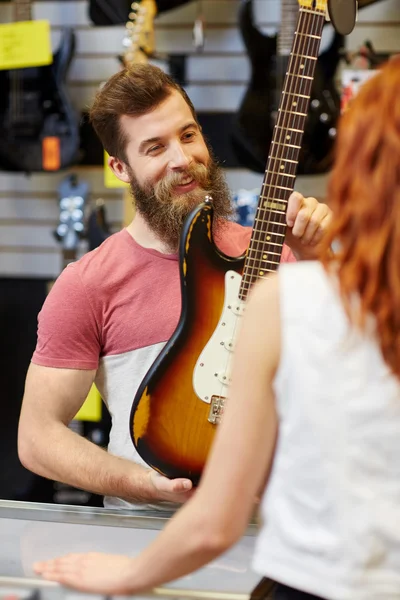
[0,21,53,69]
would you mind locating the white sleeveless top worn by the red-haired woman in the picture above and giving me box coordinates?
[253,262,400,600]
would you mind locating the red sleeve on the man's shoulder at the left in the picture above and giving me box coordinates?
[32,263,101,369]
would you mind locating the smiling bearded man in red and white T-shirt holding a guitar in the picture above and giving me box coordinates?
[18,65,331,508]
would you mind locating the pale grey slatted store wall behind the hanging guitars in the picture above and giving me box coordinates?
[0,0,400,278]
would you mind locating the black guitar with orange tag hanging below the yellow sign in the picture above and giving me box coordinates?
[0,0,79,173]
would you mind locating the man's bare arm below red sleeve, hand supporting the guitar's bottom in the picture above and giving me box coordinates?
[18,363,191,502]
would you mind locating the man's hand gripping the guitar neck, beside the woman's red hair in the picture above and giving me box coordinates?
[285,192,332,260]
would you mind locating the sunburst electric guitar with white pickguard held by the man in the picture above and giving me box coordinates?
[130,0,327,484]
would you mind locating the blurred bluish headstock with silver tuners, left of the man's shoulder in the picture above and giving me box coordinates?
[54,174,89,261]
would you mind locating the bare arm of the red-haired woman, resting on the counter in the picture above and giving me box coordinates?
[35,276,280,594]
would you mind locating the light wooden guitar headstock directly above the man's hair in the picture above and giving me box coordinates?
[121,0,157,66]
